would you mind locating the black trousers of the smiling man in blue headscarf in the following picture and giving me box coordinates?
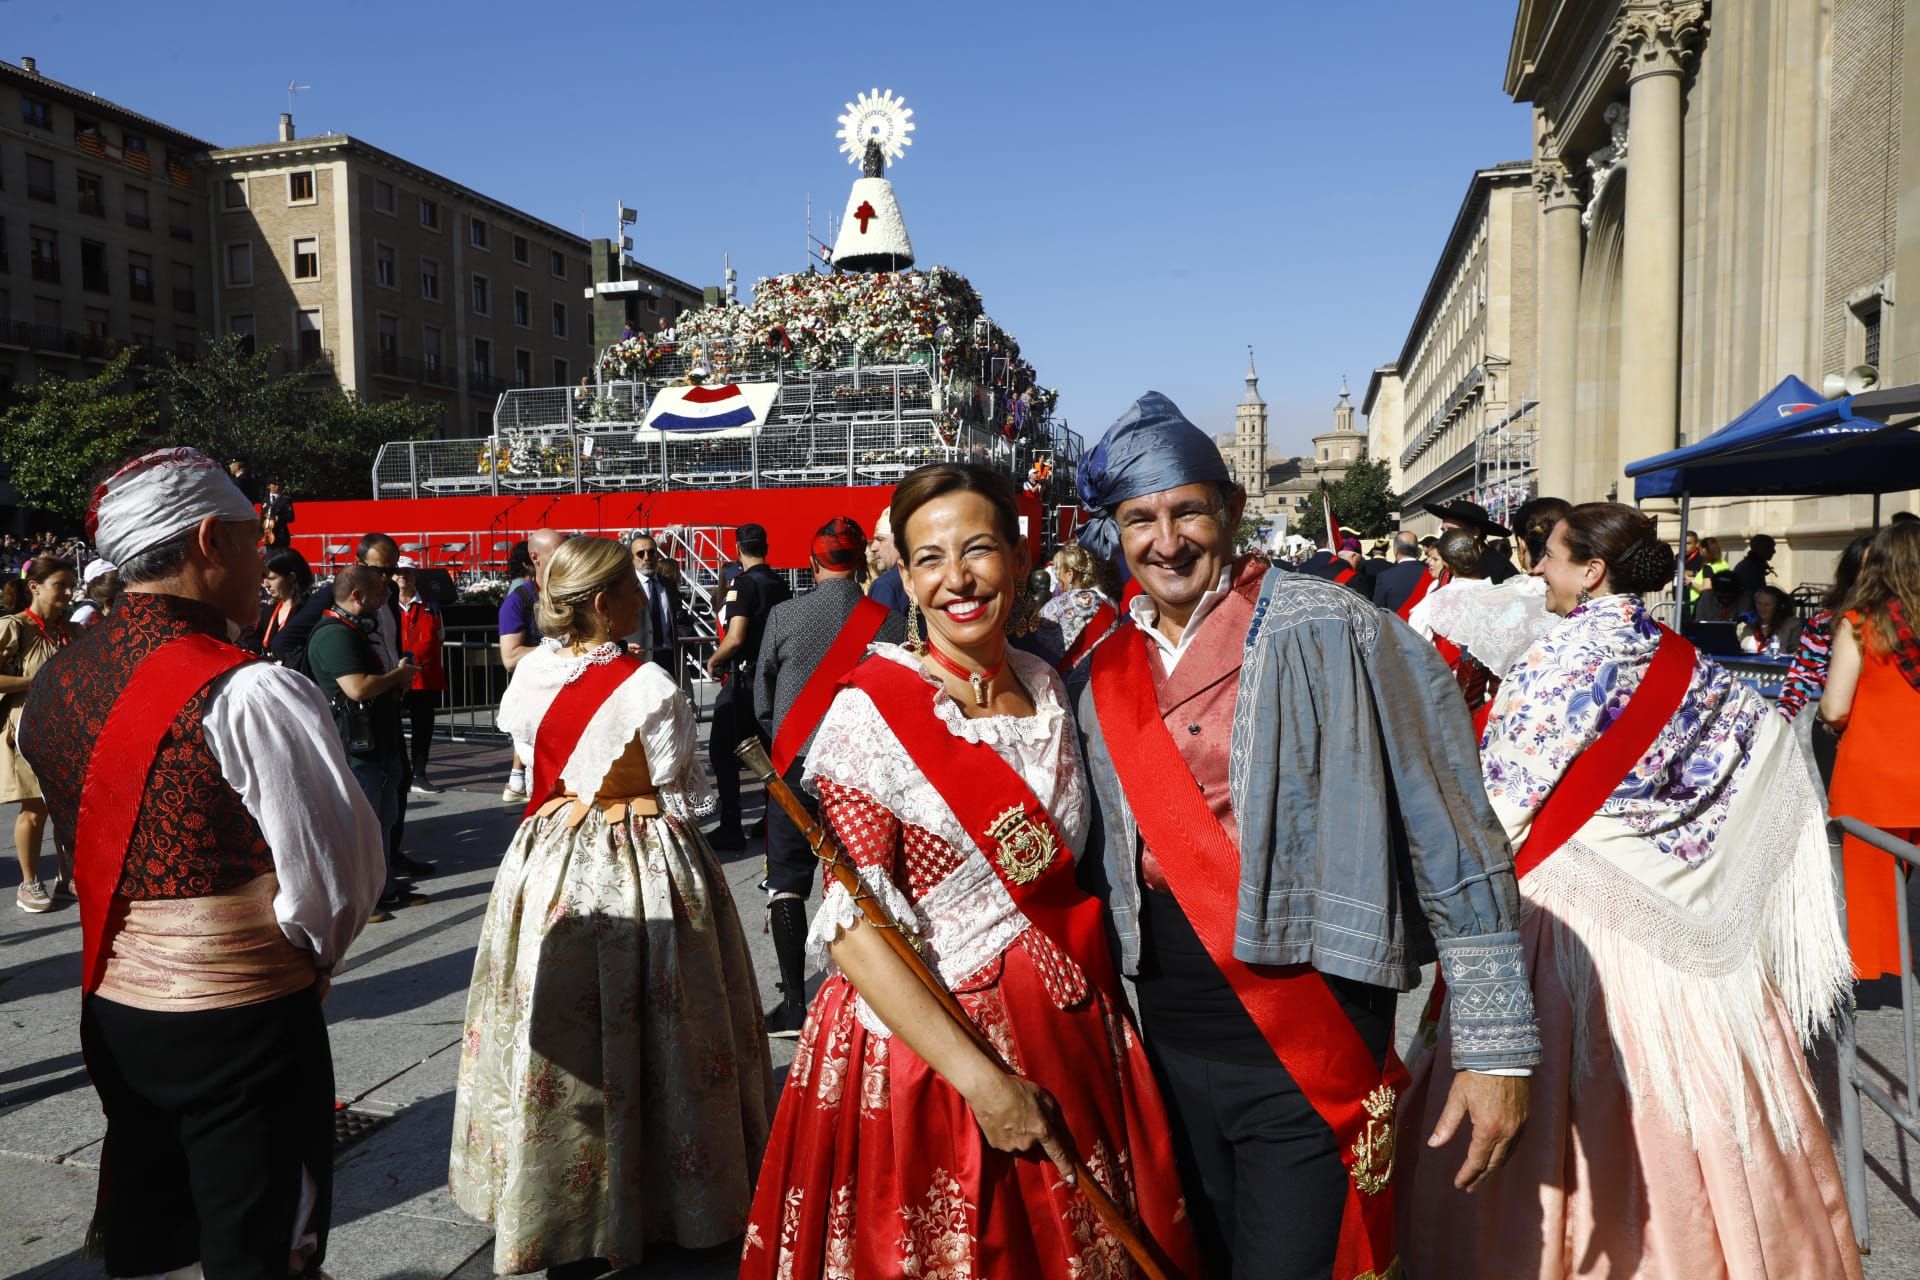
[1144,983,1394,1280]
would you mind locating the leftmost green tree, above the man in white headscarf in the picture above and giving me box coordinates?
[0,347,159,520]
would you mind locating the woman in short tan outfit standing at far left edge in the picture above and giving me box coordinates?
[0,557,77,913]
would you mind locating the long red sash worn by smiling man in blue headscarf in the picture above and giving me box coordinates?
[1092,628,1407,1280]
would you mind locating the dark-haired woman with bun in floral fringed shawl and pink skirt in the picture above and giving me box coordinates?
[1400,503,1858,1280]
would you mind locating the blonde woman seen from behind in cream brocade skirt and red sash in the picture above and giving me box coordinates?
[449,537,774,1280]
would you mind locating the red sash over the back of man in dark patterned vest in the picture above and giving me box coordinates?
[73,633,253,994]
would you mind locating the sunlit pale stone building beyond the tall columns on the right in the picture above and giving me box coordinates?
[1361,161,1538,533]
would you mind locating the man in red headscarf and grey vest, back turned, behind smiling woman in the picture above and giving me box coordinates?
[753,516,906,1036]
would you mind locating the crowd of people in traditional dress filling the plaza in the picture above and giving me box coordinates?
[15,404,1920,1280]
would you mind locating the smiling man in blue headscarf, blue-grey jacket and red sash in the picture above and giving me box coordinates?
[1079,393,1540,1280]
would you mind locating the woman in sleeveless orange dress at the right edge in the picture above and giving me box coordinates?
[1820,520,1920,979]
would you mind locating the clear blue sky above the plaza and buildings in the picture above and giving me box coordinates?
[11,0,1528,451]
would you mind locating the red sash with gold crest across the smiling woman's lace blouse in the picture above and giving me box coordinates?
[847,662,1125,1009]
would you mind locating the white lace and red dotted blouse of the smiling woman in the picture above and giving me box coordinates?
[804,645,1087,1034]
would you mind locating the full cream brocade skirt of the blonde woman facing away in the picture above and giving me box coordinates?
[449,808,774,1276]
